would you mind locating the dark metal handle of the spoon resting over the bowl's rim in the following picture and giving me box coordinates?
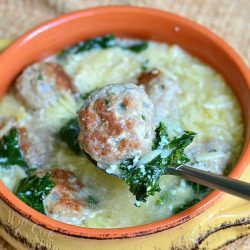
[166,166,250,200]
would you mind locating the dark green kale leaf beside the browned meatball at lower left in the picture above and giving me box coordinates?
[16,173,55,214]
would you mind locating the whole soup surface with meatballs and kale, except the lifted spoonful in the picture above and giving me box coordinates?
[0,36,243,228]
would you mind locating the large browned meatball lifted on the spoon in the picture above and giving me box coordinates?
[79,83,155,164]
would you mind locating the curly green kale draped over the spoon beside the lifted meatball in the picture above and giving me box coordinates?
[119,123,195,205]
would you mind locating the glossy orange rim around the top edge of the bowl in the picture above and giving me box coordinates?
[0,5,250,240]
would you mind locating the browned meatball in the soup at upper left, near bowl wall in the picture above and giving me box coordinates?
[15,62,72,110]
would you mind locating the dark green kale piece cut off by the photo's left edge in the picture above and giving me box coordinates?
[0,127,28,168]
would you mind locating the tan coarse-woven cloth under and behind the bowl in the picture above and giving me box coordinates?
[0,0,250,250]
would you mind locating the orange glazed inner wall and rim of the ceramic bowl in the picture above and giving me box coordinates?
[0,6,250,239]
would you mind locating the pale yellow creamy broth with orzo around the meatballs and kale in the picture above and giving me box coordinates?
[0,40,243,228]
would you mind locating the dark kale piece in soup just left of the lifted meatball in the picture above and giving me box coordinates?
[59,118,83,155]
